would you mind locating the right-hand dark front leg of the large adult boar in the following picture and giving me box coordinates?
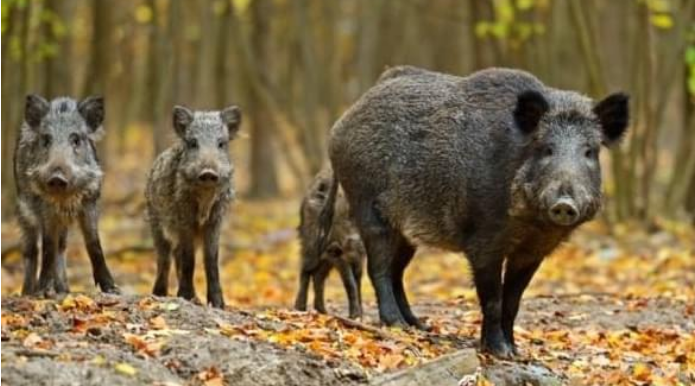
[502,257,542,354]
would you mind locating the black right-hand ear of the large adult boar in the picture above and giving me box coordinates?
[594,92,630,146]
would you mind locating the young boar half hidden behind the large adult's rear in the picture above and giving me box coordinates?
[295,168,365,318]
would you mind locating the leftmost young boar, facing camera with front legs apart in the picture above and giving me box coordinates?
[14,95,118,296]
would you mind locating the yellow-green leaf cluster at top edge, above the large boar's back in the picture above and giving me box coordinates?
[475,0,549,48]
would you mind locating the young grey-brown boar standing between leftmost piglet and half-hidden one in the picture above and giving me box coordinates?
[145,106,241,308]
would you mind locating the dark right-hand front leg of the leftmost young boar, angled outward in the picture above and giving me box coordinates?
[80,205,120,293]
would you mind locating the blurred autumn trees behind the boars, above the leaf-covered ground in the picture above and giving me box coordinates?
[2,0,695,220]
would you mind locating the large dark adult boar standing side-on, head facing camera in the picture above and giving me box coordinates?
[322,67,628,357]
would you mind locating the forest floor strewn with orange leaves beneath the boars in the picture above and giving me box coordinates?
[2,200,695,386]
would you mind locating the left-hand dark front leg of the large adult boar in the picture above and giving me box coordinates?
[468,244,512,358]
